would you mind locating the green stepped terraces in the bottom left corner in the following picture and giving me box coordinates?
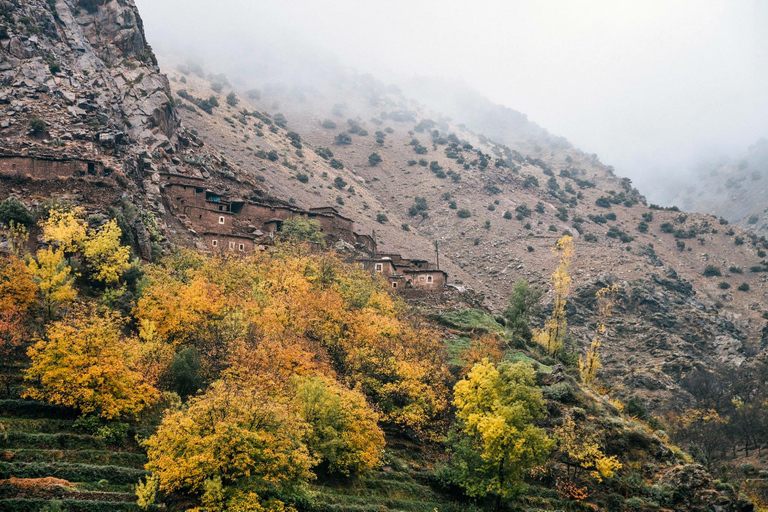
[0,400,152,512]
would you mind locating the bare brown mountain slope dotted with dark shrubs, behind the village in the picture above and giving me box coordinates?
[158,61,766,412]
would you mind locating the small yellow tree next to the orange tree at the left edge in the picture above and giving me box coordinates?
[29,248,77,319]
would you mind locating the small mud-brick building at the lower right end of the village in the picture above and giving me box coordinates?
[358,254,448,291]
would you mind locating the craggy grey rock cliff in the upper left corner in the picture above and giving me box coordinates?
[0,0,180,151]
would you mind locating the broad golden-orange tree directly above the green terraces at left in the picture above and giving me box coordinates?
[24,308,158,419]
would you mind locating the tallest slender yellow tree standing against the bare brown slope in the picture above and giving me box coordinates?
[534,235,574,355]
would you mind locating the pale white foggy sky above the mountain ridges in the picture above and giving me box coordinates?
[136,0,768,202]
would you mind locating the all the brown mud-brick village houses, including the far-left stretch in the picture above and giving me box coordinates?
[0,148,448,291]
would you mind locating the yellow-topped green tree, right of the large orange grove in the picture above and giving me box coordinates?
[454,361,553,510]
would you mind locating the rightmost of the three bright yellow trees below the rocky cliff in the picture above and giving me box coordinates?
[83,219,131,284]
